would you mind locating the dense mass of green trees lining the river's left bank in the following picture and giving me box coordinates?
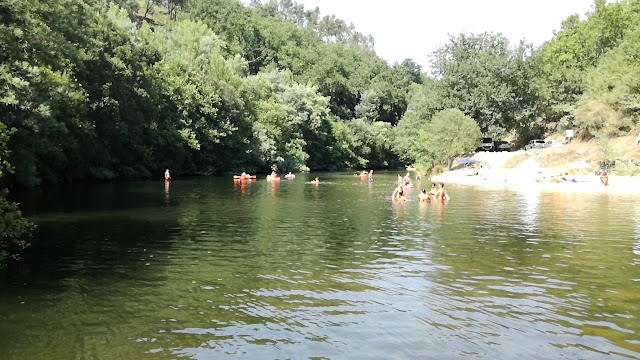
[0,0,410,186]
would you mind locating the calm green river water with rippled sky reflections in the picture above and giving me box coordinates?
[0,173,640,360]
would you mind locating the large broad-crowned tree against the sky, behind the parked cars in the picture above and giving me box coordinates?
[432,33,536,133]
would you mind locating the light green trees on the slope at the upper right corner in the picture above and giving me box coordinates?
[532,0,640,136]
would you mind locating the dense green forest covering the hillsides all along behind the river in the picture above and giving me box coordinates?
[0,0,640,262]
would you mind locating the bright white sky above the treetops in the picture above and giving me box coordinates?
[293,0,609,72]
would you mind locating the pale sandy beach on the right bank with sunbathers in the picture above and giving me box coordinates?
[431,153,640,195]
